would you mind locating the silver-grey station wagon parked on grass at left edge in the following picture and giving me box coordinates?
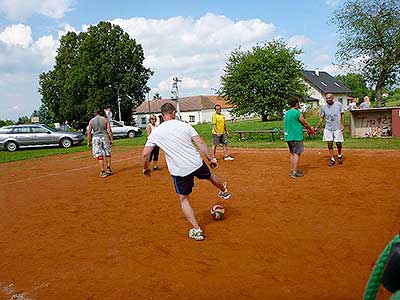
[0,124,84,152]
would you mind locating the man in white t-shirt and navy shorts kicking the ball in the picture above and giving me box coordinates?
[142,103,231,241]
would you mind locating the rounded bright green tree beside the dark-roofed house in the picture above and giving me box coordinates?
[218,41,306,121]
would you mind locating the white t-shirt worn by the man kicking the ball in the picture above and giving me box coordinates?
[146,120,203,176]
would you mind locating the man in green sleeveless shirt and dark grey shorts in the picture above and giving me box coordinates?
[284,98,313,178]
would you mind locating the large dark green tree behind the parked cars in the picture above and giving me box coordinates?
[39,22,152,128]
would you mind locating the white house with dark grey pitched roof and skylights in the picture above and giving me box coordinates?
[303,70,351,108]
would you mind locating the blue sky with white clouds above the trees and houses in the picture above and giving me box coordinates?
[0,0,341,120]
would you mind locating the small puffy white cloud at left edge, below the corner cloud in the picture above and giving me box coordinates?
[0,24,32,48]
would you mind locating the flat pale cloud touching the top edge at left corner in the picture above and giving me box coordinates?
[0,0,74,20]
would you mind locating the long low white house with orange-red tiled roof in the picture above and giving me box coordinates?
[133,96,233,128]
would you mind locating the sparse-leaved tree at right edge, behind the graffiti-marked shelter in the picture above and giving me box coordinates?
[332,0,400,107]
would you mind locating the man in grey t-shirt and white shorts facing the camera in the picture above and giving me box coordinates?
[315,93,344,166]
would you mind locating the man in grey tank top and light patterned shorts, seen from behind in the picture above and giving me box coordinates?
[88,108,114,177]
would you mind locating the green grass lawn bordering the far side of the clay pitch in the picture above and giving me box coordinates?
[0,113,400,163]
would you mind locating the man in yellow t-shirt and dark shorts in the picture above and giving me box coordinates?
[212,104,234,160]
